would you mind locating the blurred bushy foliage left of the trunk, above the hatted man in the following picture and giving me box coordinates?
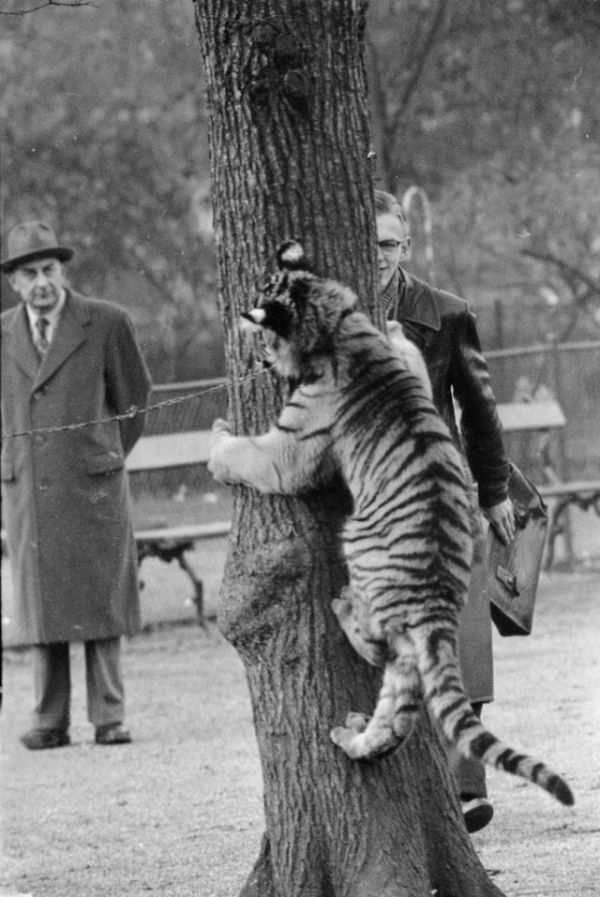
[0,0,222,380]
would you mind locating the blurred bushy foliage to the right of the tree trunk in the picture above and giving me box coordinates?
[369,0,600,344]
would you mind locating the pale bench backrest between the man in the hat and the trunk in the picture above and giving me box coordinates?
[127,430,211,473]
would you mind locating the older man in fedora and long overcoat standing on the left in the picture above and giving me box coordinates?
[0,221,150,750]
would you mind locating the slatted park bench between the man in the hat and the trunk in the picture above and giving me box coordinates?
[127,430,231,625]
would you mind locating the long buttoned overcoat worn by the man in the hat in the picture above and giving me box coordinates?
[2,291,150,644]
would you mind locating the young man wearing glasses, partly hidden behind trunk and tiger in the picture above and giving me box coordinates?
[375,190,515,832]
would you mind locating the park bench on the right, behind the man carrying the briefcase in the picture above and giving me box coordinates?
[498,399,600,570]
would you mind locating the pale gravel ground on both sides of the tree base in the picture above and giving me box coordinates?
[0,515,600,897]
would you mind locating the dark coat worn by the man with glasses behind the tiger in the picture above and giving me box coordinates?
[391,271,509,701]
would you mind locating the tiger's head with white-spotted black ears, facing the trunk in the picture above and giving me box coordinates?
[242,240,356,379]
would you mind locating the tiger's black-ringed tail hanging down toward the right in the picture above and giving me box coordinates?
[415,627,575,806]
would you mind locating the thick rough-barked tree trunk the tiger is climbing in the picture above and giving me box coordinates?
[196,0,501,897]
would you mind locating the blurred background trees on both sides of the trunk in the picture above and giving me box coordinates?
[0,0,600,374]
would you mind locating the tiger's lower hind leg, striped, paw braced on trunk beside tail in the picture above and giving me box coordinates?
[331,635,421,760]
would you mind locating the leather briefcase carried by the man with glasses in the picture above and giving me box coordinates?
[484,464,548,635]
